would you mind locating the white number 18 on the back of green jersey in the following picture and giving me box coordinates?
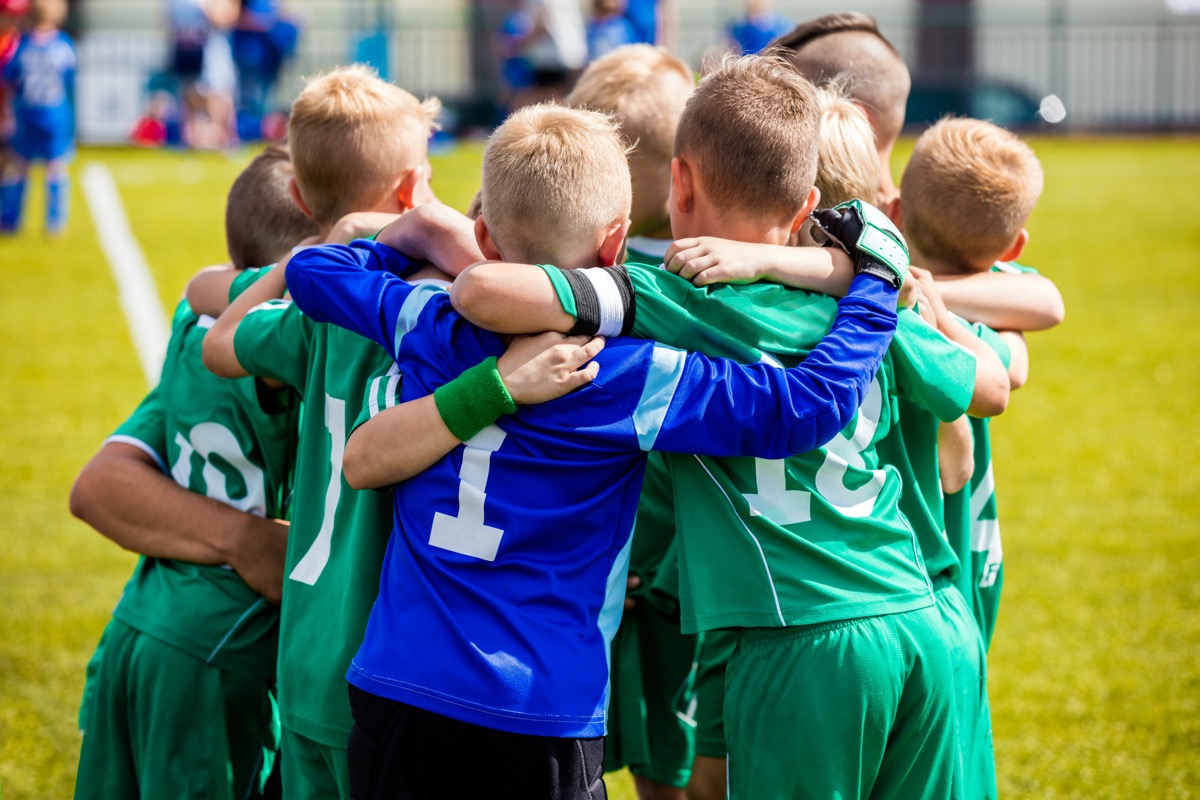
[744,379,884,525]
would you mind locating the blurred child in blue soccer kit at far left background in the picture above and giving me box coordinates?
[0,0,76,234]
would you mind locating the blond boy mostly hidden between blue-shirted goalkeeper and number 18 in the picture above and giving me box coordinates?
[566,44,715,800]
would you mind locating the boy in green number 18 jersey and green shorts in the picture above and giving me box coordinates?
[455,58,1008,798]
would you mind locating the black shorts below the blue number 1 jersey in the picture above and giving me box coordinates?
[349,686,608,800]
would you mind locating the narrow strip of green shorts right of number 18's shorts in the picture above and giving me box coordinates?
[934,578,996,800]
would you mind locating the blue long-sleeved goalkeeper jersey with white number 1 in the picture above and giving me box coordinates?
[288,241,896,738]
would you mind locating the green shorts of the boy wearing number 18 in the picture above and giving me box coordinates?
[725,606,962,800]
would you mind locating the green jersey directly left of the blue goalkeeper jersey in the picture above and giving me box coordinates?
[234,291,405,747]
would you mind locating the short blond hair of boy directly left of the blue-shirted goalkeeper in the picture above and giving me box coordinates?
[288,64,442,225]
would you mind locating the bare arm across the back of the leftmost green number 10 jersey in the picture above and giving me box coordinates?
[71,441,288,603]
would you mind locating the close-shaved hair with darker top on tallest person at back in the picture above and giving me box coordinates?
[774,11,912,148]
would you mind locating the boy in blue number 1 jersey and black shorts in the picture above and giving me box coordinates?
[280,107,904,798]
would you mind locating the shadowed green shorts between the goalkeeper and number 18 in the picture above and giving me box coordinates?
[604,602,698,788]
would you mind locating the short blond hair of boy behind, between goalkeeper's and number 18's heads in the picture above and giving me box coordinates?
[565,44,695,161]
